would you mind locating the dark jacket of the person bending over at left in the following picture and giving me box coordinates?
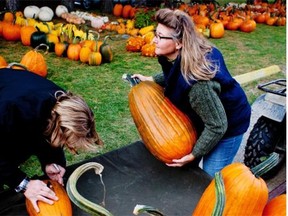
[0,69,66,188]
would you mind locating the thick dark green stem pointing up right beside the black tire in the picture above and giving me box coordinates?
[251,152,279,178]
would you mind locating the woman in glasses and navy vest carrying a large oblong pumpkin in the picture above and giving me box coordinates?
[132,8,251,176]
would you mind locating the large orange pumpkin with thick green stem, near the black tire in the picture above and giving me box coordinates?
[192,153,279,216]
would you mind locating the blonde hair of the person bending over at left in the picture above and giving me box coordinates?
[45,91,103,150]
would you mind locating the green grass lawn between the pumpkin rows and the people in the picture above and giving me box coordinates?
[0,4,286,175]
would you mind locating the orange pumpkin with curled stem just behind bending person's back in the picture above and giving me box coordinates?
[20,44,49,77]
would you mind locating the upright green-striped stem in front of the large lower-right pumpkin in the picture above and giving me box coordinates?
[212,172,226,216]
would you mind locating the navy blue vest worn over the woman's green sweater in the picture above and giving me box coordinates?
[158,48,251,137]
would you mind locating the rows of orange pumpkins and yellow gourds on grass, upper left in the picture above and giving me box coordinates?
[0,8,113,72]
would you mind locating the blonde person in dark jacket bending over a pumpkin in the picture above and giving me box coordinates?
[0,68,102,212]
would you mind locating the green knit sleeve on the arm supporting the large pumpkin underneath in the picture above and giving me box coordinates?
[189,81,228,157]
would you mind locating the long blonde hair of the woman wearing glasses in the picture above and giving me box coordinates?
[155,8,218,83]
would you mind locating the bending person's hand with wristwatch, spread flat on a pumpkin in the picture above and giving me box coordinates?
[24,180,58,213]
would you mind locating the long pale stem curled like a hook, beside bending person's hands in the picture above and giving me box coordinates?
[66,162,112,216]
